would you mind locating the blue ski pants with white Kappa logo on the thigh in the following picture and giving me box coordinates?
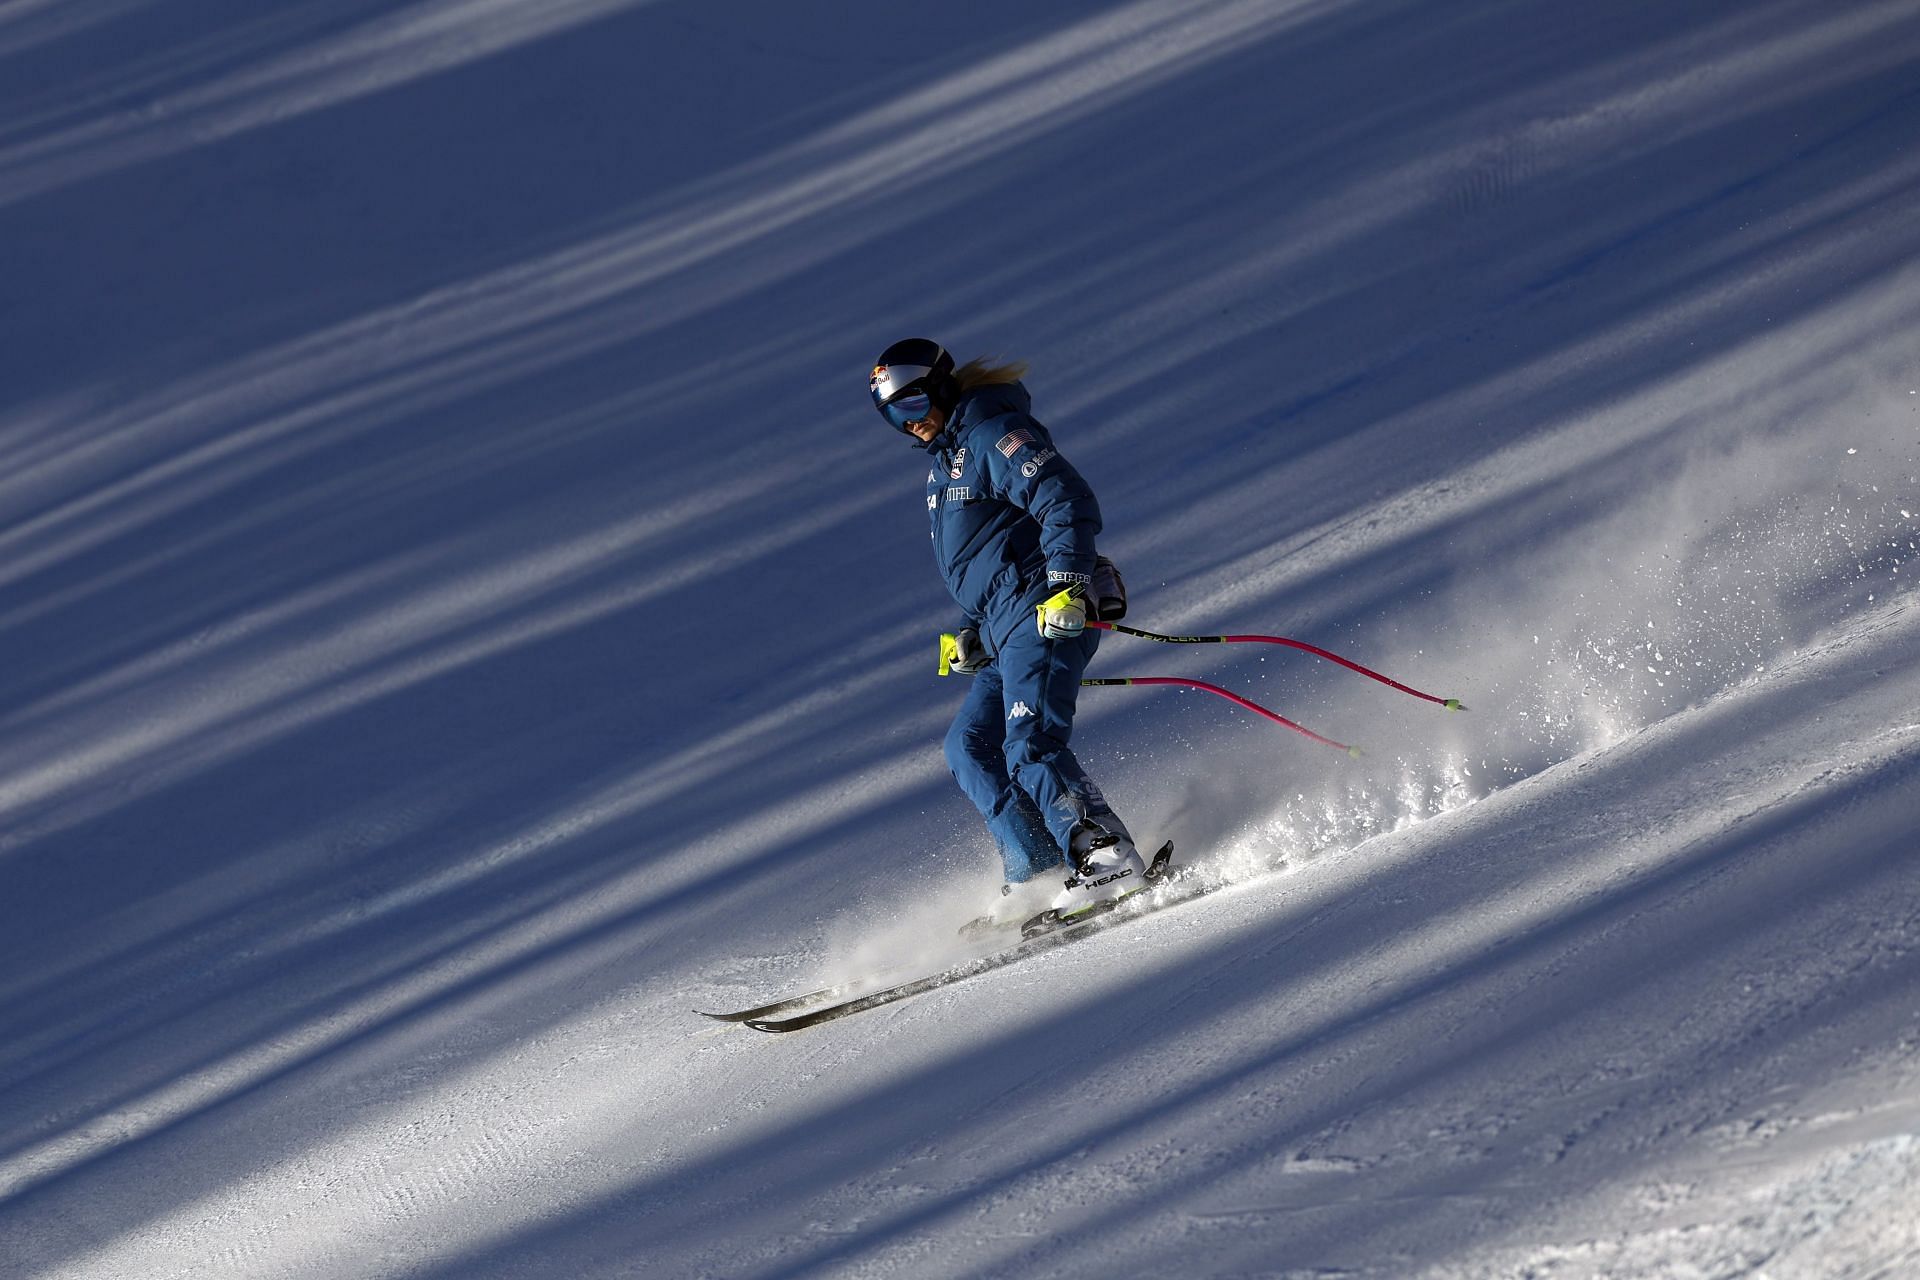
[947,626,1131,885]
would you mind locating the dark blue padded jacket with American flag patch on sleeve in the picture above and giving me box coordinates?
[927,382,1100,652]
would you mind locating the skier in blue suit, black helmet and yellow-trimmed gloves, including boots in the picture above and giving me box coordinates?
[868,338,1146,925]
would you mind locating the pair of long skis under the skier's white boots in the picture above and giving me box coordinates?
[701,841,1182,1032]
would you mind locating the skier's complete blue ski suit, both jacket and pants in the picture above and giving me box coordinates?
[927,382,1131,883]
